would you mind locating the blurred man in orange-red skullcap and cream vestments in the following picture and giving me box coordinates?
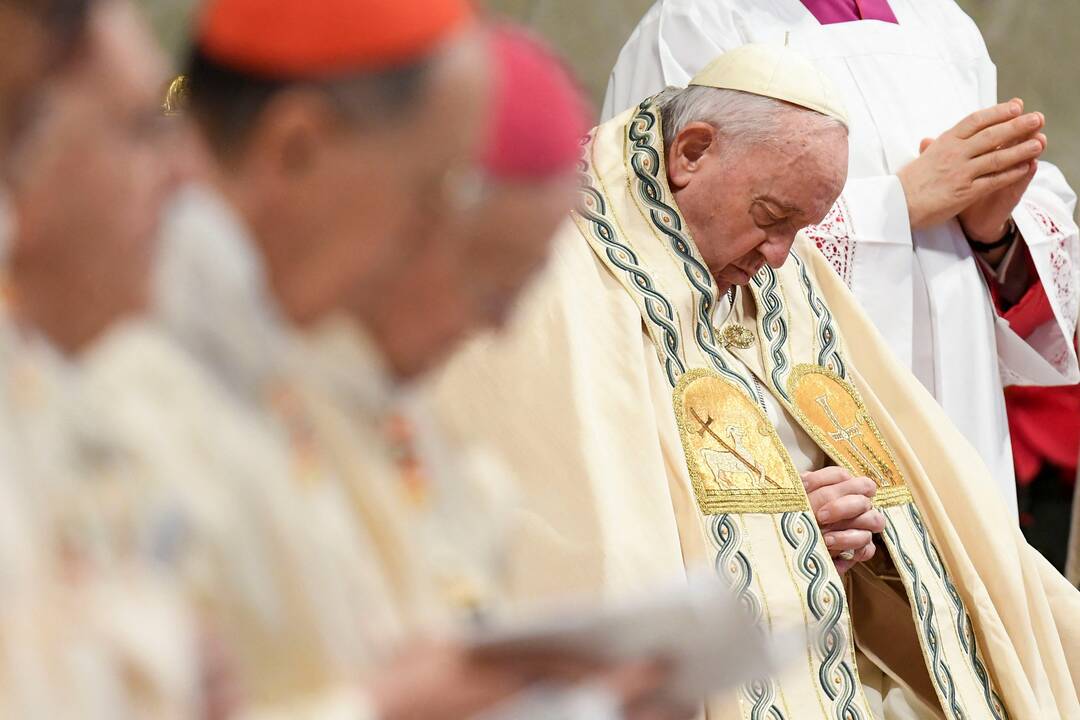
[150,0,682,719]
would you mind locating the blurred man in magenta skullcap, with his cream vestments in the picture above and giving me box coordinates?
[334,26,588,613]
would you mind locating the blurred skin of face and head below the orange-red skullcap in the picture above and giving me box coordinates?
[192,27,490,325]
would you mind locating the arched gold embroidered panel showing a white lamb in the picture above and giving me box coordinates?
[674,369,809,515]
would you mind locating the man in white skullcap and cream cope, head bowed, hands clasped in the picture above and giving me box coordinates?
[434,45,1080,720]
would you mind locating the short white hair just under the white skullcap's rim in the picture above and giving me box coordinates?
[653,85,847,147]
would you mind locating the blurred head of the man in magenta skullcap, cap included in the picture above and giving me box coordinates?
[341,24,588,380]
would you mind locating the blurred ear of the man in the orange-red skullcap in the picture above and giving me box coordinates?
[244,90,340,182]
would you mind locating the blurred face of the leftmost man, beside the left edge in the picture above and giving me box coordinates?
[9,0,181,353]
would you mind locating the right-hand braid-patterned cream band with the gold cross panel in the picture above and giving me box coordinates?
[732,268,1009,720]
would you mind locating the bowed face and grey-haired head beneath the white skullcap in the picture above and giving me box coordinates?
[665,89,848,291]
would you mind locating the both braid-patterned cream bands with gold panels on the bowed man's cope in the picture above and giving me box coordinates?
[575,100,1008,720]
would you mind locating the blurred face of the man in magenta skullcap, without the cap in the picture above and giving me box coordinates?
[351,172,578,380]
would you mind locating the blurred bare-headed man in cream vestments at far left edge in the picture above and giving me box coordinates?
[0,0,200,718]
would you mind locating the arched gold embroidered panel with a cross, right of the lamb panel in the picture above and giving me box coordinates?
[787,365,912,507]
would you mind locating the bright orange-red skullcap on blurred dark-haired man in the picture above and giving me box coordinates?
[195,0,473,78]
